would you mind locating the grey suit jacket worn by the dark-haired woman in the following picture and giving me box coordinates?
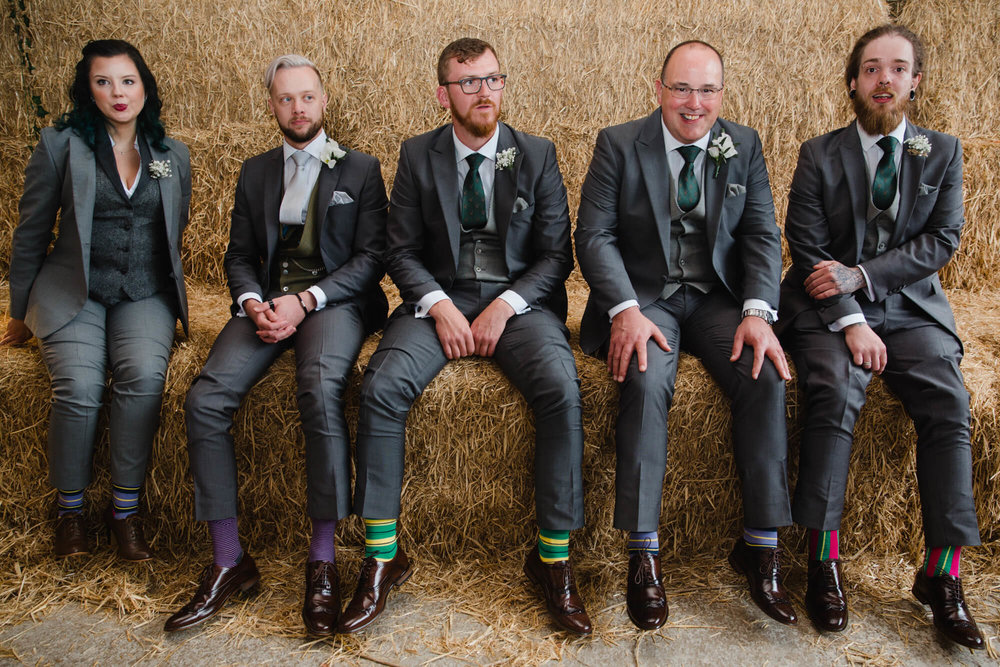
[10,127,191,338]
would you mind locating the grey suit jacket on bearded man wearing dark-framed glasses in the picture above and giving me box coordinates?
[387,123,573,320]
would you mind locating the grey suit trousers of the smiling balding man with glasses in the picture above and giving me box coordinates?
[614,286,791,531]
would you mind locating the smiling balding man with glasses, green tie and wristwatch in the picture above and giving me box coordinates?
[576,41,797,630]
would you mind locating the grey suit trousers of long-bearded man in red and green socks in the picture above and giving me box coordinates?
[787,294,980,547]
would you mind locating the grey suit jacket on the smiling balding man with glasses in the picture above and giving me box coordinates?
[575,109,781,354]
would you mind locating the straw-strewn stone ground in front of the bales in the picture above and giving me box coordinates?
[0,587,1000,666]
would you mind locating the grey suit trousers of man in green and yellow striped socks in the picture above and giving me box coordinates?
[354,281,583,530]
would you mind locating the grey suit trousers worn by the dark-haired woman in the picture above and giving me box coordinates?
[39,294,177,491]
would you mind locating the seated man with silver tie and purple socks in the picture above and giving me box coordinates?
[164,55,388,635]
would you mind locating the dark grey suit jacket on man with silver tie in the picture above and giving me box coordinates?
[224,146,388,333]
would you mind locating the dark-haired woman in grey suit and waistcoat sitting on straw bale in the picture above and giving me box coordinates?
[0,40,191,561]
